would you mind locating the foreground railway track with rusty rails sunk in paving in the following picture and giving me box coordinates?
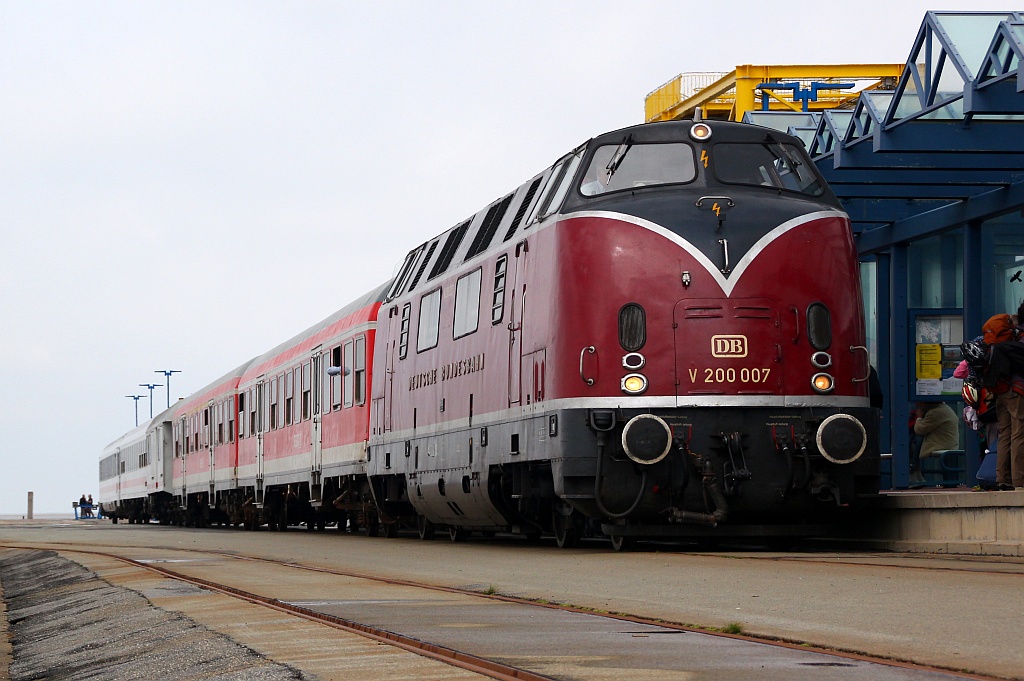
[4,543,999,680]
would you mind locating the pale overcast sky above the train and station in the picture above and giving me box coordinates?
[0,0,1006,514]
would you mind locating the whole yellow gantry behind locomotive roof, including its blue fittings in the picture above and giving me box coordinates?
[644,63,904,123]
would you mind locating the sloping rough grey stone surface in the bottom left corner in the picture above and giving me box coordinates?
[0,551,309,681]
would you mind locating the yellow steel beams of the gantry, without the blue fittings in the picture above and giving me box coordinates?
[644,63,904,123]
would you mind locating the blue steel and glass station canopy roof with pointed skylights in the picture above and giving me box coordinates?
[742,11,1024,255]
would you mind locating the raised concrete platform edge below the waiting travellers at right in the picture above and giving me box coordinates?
[854,487,1024,557]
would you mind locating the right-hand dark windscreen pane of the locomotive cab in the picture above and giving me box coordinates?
[711,141,824,197]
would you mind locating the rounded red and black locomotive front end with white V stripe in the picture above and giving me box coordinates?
[555,115,879,546]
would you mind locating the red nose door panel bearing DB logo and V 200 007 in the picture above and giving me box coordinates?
[673,298,793,406]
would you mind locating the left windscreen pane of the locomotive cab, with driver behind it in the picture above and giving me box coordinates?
[580,142,697,197]
